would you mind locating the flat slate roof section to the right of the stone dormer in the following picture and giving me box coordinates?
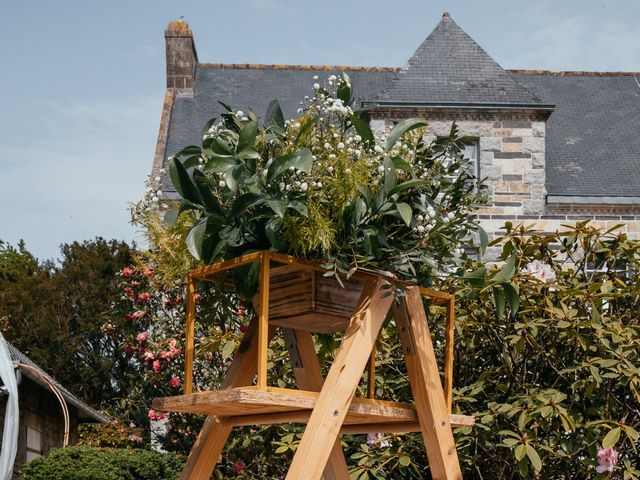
[513,73,640,197]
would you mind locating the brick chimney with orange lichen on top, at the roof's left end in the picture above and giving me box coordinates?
[164,18,198,94]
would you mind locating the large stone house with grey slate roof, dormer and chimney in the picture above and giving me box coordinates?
[152,13,640,256]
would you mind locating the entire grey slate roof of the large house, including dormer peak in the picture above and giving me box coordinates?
[162,14,640,203]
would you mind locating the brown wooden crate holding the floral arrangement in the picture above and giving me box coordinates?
[253,265,363,333]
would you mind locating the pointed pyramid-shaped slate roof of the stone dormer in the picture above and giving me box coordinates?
[378,13,541,105]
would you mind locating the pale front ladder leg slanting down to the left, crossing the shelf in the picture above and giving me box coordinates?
[286,278,393,480]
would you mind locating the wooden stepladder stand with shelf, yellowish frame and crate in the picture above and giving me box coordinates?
[153,252,474,480]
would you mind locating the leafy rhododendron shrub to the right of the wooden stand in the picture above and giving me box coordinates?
[447,223,640,479]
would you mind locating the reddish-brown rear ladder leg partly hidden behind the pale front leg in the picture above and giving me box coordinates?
[283,329,349,480]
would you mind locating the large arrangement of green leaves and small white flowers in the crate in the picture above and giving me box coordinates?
[165,74,481,294]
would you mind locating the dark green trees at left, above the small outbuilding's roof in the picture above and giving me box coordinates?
[0,238,131,406]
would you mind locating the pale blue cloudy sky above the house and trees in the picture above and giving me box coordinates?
[0,0,640,258]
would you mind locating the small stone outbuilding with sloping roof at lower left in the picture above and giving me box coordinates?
[0,342,108,479]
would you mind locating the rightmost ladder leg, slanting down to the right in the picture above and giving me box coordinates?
[393,287,462,480]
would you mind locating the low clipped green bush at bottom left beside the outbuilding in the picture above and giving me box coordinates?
[20,446,183,480]
